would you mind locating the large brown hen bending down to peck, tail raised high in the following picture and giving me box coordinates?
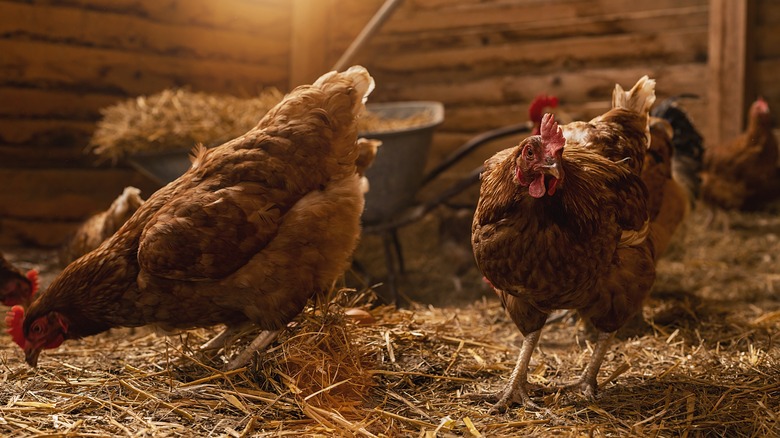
[10,66,374,368]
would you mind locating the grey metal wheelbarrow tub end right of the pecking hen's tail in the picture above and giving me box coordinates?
[359,101,444,224]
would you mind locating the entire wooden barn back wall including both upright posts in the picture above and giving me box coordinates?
[0,0,780,246]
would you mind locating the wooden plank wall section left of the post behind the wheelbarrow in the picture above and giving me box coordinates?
[0,0,291,245]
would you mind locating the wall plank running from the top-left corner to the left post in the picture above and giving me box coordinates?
[0,2,290,64]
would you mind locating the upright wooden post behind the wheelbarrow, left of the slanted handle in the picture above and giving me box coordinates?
[289,0,333,89]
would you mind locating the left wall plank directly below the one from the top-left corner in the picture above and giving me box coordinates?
[0,40,287,96]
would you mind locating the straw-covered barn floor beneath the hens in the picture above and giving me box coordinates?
[0,200,780,437]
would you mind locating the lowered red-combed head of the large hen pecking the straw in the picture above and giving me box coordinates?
[5,306,68,367]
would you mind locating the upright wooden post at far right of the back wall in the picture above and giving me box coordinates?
[707,0,755,144]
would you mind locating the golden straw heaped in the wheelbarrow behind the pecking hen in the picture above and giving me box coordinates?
[89,88,433,163]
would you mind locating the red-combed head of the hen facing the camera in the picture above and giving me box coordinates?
[515,113,566,198]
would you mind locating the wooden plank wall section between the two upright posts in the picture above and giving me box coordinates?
[346,0,708,180]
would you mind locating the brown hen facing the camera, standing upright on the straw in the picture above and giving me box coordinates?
[472,77,655,410]
